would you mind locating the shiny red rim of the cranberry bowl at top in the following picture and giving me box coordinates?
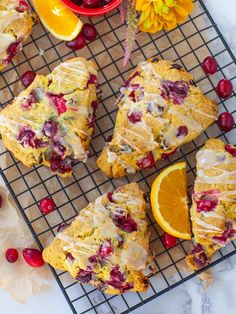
[62,0,122,16]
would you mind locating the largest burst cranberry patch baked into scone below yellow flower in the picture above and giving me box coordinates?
[161,80,189,105]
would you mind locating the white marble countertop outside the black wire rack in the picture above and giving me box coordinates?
[0,0,236,314]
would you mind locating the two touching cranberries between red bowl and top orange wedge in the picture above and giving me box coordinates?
[66,23,97,50]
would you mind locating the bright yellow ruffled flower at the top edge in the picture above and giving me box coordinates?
[135,0,194,33]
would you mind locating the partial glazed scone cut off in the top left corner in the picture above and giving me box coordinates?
[0,0,33,71]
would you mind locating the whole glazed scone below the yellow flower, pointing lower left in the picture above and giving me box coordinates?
[98,59,217,177]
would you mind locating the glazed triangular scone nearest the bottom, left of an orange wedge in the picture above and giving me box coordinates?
[43,183,150,294]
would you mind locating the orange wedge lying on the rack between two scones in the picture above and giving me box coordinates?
[151,162,191,240]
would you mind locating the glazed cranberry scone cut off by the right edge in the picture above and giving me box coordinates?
[187,139,236,269]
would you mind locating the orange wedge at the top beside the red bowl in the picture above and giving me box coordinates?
[32,0,83,41]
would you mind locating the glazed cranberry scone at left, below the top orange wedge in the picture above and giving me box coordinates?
[0,57,98,176]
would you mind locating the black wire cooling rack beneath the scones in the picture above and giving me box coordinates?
[0,0,236,314]
